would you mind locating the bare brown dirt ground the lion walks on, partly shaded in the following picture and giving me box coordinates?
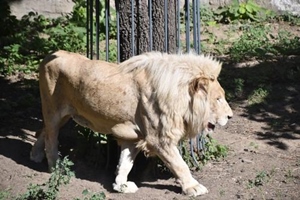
[0,54,300,200]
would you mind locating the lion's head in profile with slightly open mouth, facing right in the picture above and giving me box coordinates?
[189,73,233,137]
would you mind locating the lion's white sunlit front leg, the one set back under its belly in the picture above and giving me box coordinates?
[113,143,139,193]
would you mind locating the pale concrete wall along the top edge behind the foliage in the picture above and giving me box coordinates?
[8,0,300,18]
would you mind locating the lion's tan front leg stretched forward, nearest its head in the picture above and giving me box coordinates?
[157,145,208,196]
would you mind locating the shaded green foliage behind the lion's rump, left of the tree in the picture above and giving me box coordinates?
[0,0,117,75]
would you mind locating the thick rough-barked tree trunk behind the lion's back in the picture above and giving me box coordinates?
[115,0,177,61]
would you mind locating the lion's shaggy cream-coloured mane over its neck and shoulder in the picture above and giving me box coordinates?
[120,52,221,152]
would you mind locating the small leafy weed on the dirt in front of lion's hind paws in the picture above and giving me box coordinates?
[17,157,74,200]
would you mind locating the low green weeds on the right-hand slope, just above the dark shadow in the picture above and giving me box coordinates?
[229,24,300,61]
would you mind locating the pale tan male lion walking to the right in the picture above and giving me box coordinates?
[31,50,233,196]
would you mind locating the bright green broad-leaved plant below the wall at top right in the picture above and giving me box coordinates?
[215,0,273,23]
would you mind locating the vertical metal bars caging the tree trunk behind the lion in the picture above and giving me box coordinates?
[86,0,205,166]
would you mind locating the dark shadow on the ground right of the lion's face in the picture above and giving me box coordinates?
[220,56,300,150]
